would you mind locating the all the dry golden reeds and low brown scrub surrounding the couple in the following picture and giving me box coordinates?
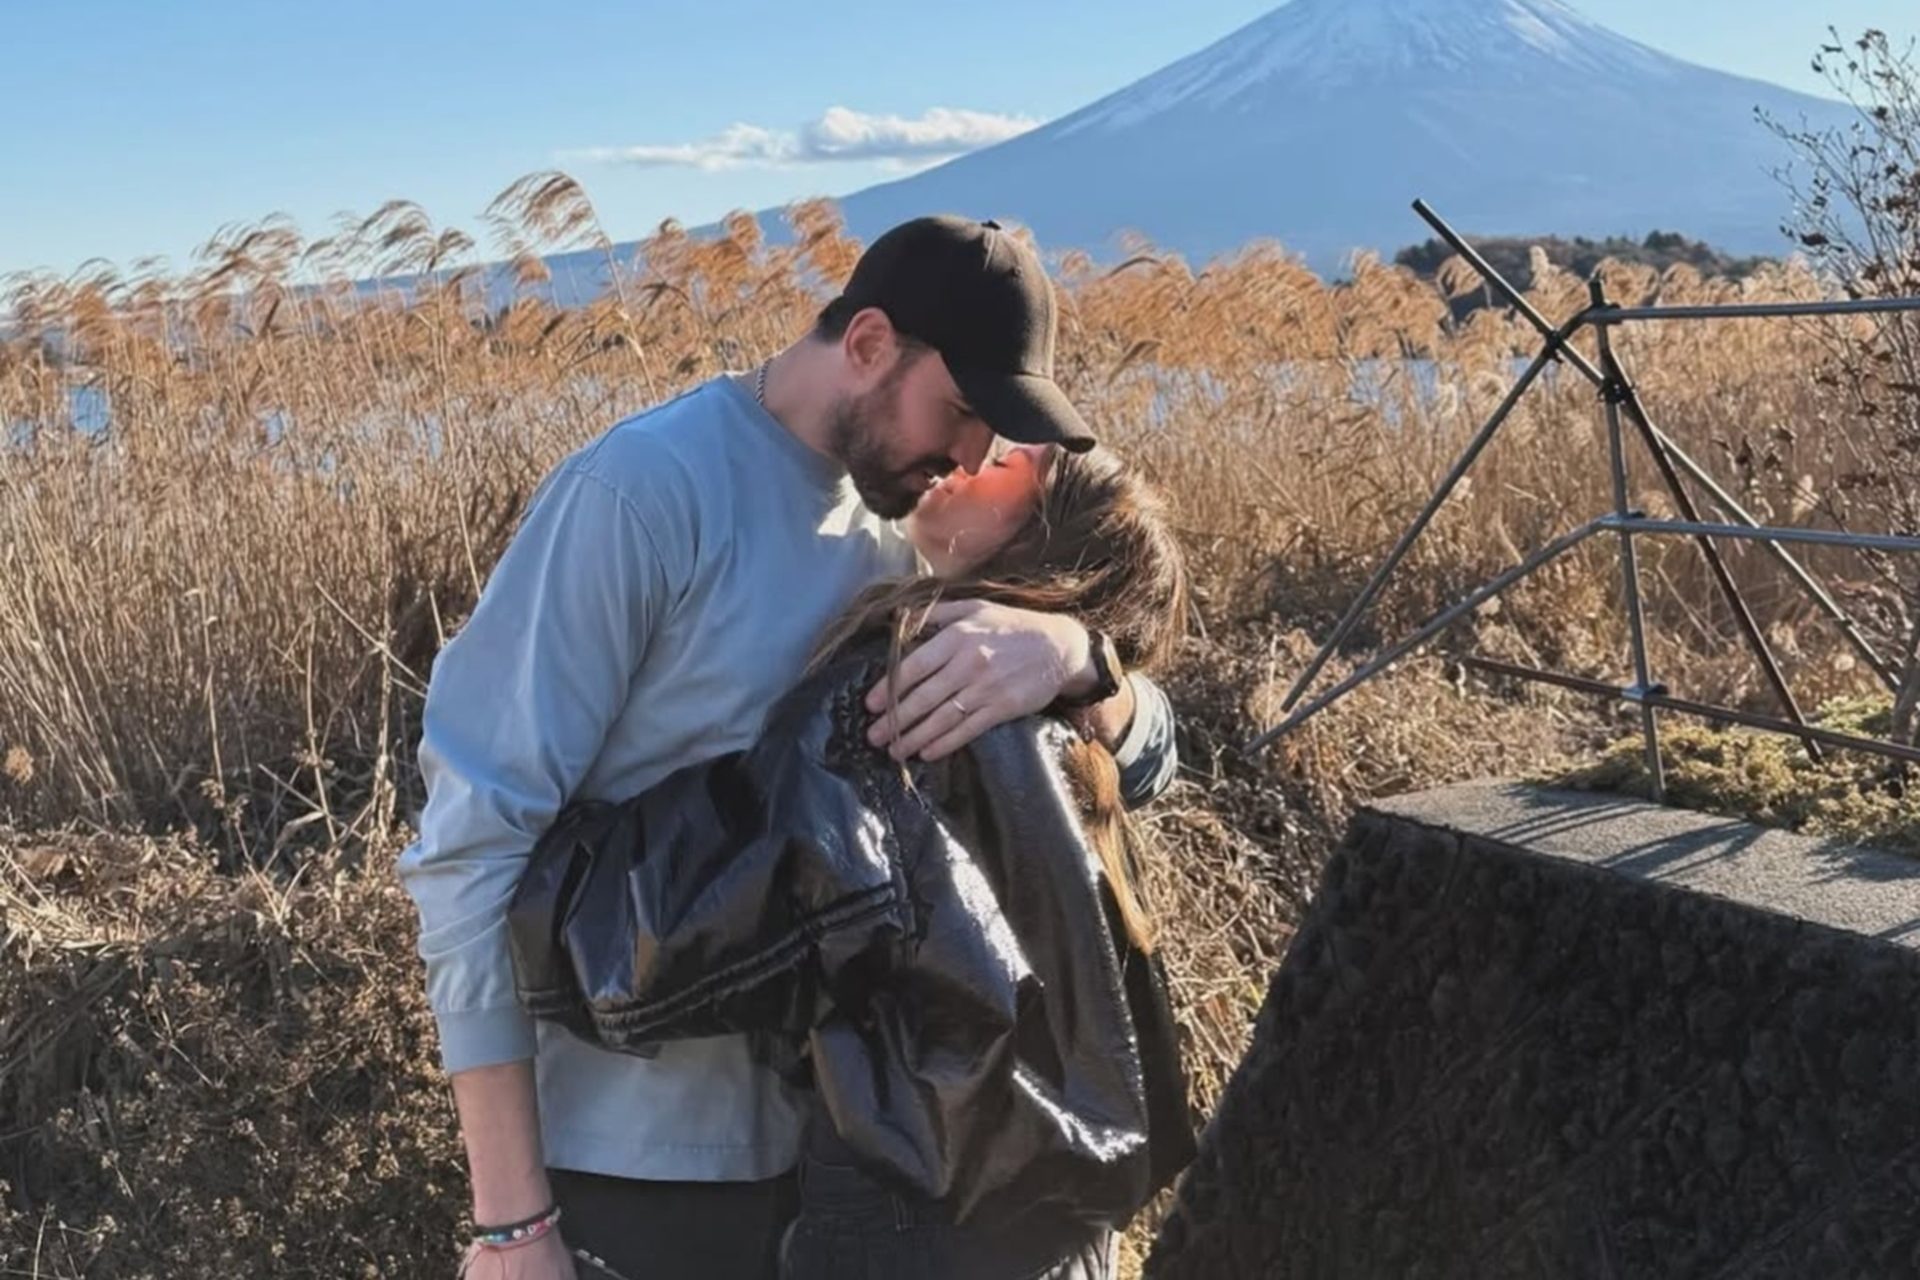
[0,175,1899,1278]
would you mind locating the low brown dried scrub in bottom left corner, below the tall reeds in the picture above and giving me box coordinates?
[0,829,467,1280]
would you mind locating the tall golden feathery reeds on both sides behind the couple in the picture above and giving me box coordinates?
[0,189,1891,840]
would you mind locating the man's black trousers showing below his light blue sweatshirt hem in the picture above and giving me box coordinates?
[547,1169,799,1280]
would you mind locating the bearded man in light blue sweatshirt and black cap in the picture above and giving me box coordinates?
[399,219,1173,1280]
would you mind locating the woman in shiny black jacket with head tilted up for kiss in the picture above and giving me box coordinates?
[509,447,1192,1280]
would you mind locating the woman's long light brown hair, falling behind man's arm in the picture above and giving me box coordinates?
[812,449,1187,952]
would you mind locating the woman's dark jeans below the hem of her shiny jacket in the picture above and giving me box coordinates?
[780,1132,1116,1280]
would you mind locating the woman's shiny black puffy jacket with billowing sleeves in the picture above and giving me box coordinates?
[509,649,1194,1226]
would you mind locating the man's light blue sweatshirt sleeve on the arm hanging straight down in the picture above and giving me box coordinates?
[397,462,672,1073]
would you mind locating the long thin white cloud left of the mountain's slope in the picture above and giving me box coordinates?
[566,107,1041,171]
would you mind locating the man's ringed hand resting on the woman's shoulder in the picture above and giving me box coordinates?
[866,601,1098,760]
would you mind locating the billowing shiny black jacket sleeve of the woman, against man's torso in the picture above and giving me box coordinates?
[507,681,912,1055]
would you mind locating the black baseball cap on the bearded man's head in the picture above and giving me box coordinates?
[839,215,1094,453]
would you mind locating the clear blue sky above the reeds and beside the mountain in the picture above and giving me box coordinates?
[0,0,1920,274]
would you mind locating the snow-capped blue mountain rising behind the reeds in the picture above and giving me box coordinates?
[762,0,1855,274]
